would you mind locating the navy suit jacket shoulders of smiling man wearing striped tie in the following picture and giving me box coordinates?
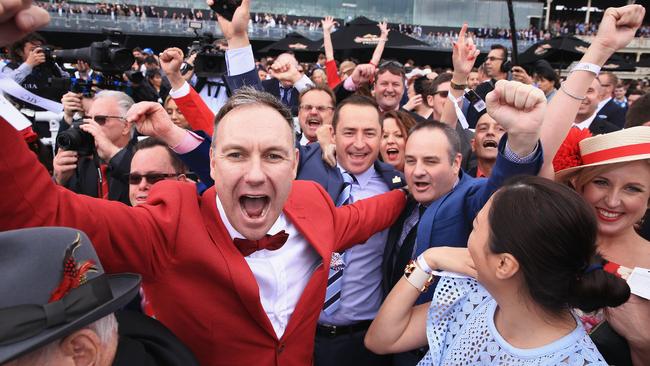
[296,144,406,202]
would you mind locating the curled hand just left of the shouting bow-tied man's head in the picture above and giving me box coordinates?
[126,102,187,146]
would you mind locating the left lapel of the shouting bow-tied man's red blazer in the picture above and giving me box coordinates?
[201,187,277,338]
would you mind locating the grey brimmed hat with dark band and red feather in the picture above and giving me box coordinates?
[0,227,140,364]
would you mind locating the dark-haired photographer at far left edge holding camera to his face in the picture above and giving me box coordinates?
[2,33,69,110]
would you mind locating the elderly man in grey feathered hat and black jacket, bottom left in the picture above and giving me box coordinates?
[0,227,198,366]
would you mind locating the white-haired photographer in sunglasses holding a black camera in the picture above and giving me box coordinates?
[53,90,135,204]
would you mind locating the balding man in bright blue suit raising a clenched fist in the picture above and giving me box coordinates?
[382,80,546,365]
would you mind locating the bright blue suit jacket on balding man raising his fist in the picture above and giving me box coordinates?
[384,134,543,303]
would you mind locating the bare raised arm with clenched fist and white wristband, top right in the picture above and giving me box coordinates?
[540,5,645,179]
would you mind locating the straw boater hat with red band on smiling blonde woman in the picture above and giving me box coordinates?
[555,126,650,181]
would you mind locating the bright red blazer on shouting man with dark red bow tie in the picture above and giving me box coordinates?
[0,119,405,366]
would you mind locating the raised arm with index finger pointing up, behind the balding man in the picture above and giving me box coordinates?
[440,24,480,129]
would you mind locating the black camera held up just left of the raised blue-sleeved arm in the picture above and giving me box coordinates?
[188,22,226,77]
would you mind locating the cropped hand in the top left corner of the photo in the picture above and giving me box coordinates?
[0,0,50,47]
